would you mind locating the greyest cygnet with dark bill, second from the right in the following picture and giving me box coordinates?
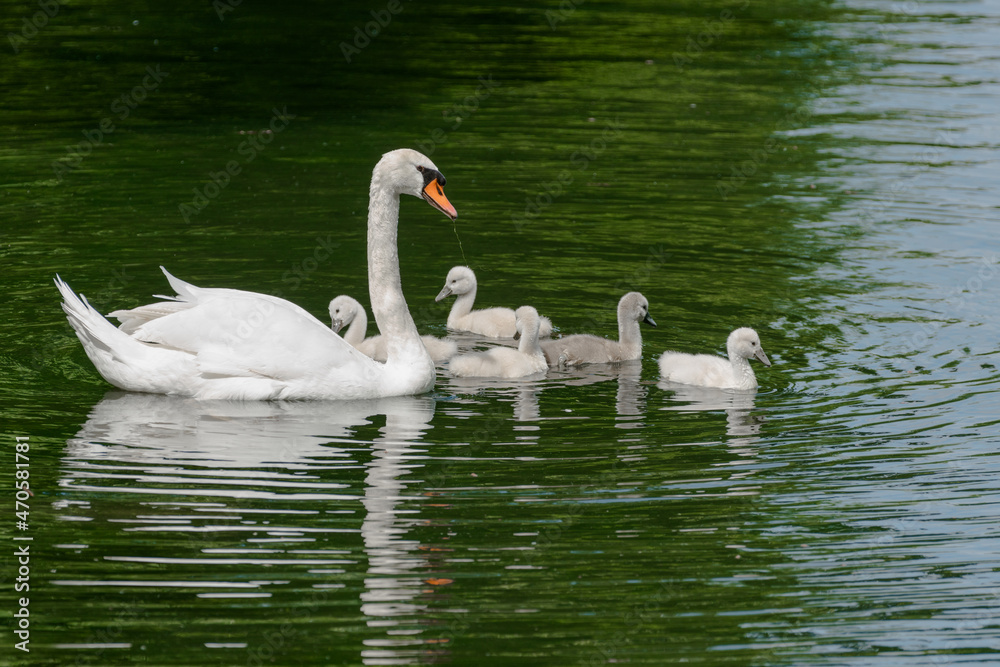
[542,292,656,366]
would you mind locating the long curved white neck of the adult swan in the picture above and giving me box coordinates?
[368,170,426,359]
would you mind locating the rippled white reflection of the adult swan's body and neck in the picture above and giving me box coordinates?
[62,392,435,664]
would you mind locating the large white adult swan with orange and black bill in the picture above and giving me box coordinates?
[56,149,458,400]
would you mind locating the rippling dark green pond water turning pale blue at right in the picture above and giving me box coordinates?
[0,0,1000,667]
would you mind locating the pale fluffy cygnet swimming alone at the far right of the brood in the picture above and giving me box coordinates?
[659,327,771,389]
